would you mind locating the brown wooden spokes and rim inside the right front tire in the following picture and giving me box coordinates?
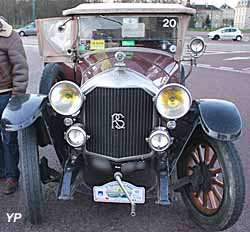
[186,144,224,215]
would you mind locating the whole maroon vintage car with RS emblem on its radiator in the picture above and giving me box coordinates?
[2,3,245,231]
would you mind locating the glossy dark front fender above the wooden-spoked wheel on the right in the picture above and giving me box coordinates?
[198,99,242,141]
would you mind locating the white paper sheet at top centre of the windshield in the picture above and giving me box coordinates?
[122,23,145,38]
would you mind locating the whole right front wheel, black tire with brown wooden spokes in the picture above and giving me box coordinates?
[178,135,245,231]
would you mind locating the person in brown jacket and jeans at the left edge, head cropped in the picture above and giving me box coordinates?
[0,16,28,194]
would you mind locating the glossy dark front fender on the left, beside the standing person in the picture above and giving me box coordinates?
[1,94,47,131]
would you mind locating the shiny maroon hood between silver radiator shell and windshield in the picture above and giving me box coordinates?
[79,48,179,83]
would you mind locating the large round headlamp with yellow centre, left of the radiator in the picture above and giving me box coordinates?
[49,81,83,115]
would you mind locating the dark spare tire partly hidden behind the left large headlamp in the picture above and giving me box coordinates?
[39,63,66,95]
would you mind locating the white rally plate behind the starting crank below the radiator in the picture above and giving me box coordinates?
[93,181,145,204]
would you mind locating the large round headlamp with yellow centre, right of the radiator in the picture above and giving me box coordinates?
[156,84,192,119]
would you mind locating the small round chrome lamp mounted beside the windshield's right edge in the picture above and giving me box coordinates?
[188,37,207,58]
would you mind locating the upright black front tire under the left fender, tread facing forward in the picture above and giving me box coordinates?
[18,126,44,224]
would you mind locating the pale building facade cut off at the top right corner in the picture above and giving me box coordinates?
[234,0,250,29]
